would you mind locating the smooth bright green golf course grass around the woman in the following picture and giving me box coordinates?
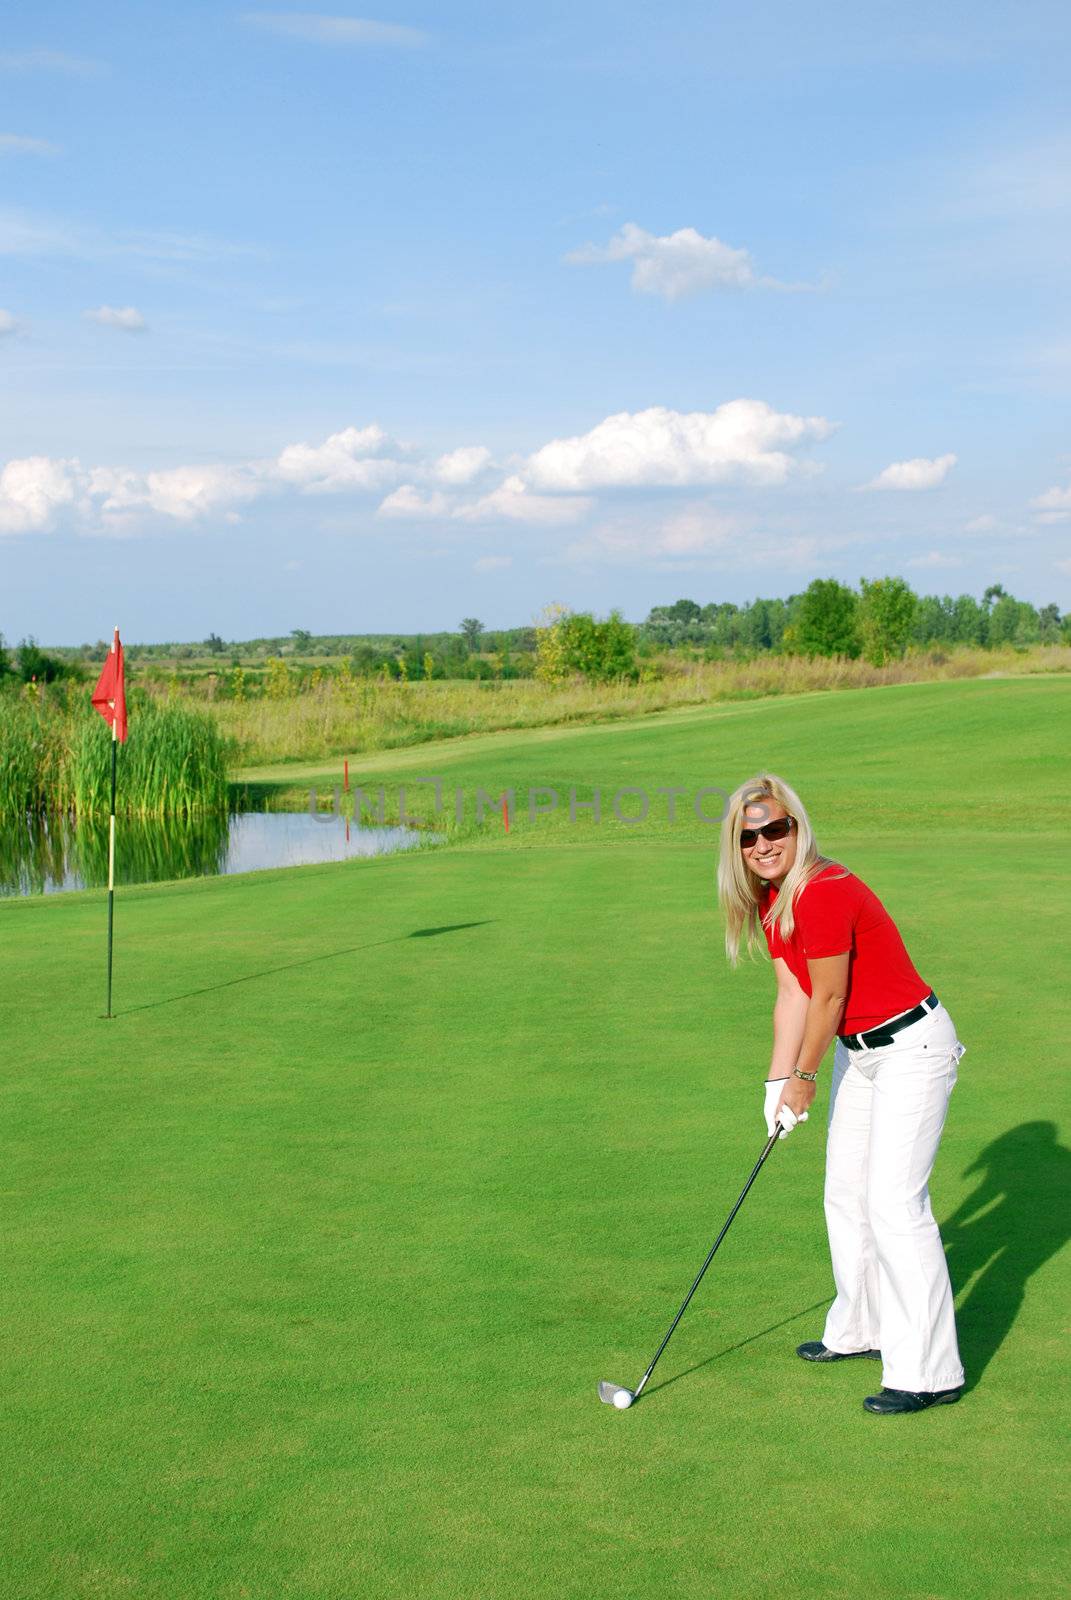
[0,678,1071,1600]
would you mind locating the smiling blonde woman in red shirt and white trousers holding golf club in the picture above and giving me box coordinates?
[717,773,964,1416]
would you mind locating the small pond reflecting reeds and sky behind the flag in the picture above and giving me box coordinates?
[0,811,440,896]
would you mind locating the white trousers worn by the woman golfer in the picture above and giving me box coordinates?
[823,1005,964,1392]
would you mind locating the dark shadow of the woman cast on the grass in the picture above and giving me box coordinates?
[941,1122,1071,1390]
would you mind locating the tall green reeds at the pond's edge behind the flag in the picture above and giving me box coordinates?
[0,694,227,819]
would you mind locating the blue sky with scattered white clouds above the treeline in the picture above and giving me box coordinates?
[0,0,1071,643]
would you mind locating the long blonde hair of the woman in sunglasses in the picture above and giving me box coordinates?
[717,773,831,966]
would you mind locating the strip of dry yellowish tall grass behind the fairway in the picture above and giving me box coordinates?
[213,645,1071,766]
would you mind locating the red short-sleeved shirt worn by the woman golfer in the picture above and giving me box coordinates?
[759,864,930,1034]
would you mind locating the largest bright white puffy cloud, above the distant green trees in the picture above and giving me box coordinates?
[522,400,834,490]
